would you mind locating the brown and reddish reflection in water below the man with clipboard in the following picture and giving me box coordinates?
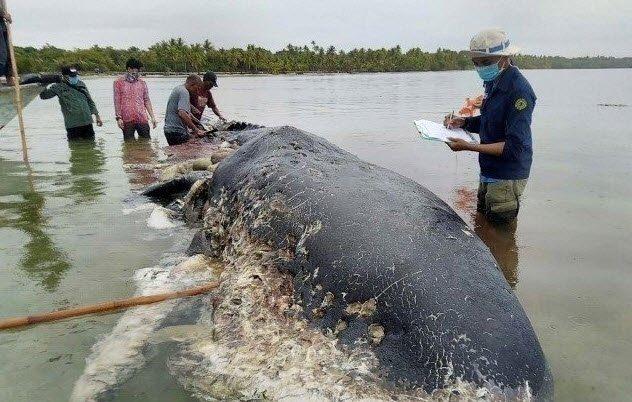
[454,187,519,288]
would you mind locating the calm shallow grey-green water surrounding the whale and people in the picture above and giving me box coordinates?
[0,70,632,401]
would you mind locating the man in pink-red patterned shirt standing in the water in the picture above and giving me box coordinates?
[114,58,156,141]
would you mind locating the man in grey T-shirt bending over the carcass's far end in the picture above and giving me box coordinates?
[165,74,204,145]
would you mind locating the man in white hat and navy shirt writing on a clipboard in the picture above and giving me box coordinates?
[444,29,536,222]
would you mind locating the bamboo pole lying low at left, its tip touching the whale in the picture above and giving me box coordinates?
[0,282,219,331]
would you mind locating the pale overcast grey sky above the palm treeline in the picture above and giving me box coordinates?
[7,0,632,56]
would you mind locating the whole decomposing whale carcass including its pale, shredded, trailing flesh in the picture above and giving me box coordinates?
[71,125,552,401]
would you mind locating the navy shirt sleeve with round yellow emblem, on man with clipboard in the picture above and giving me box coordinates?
[501,92,536,160]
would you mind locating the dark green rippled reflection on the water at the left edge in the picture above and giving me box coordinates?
[0,159,71,292]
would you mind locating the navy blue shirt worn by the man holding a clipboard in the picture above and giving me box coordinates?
[464,66,536,180]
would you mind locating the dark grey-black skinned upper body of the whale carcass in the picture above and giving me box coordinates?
[178,127,552,399]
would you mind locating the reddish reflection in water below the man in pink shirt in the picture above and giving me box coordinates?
[121,138,158,188]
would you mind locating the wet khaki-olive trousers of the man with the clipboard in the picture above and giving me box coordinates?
[476,179,527,222]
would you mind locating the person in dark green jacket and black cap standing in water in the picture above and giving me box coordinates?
[40,67,103,140]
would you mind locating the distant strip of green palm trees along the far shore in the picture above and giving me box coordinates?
[16,39,632,74]
